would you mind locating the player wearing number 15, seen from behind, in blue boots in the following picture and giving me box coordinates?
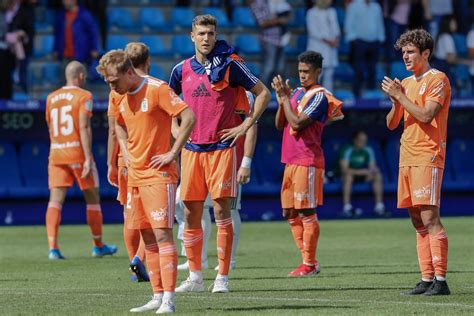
[46,61,117,260]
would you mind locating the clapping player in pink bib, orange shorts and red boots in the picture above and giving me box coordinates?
[272,51,343,277]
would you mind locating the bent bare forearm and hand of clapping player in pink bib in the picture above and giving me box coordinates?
[272,75,313,131]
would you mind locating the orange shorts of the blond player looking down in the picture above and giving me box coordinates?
[125,183,176,229]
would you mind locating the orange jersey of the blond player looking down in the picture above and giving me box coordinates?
[117,78,188,187]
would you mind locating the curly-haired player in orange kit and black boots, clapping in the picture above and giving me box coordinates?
[382,29,451,295]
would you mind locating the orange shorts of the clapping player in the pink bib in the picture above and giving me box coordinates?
[281,164,324,210]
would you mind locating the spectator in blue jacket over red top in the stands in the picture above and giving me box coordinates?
[54,0,99,65]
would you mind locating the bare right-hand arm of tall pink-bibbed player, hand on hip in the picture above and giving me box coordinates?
[220,81,271,146]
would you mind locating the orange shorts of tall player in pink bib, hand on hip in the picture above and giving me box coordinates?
[180,147,237,201]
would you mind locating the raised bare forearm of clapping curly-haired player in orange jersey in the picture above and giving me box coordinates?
[382,77,441,125]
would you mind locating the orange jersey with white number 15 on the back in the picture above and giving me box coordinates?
[46,86,92,165]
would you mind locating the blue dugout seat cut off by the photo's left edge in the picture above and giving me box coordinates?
[0,141,21,191]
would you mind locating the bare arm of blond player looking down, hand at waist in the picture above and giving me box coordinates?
[149,108,196,169]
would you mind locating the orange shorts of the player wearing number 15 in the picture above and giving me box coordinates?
[48,163,99,191]
